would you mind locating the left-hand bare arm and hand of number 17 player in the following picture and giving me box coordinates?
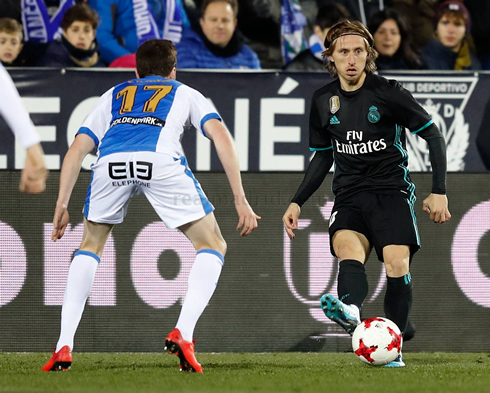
[51,134,95,242]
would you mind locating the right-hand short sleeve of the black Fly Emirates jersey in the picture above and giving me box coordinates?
[388,82,433,134]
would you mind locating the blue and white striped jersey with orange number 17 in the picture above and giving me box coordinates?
[78,75,221,158]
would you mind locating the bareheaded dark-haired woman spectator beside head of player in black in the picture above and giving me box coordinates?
[368,8,423,71]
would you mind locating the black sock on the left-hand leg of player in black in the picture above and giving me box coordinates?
[337,259,369,309]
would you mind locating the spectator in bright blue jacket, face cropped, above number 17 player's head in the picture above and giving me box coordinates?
[88,0,189,65]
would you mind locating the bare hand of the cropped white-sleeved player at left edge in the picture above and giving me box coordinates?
[19,143,48,194]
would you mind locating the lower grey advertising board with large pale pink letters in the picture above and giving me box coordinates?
[0,171,490,352]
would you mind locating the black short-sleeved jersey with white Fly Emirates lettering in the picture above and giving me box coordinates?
[310,74,432,198]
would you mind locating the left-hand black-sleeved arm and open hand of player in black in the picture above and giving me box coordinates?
[282,149,333,239]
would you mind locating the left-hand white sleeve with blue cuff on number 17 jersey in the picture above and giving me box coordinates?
[77,88,114,147]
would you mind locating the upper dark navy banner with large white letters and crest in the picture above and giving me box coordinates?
[0,68,490,172]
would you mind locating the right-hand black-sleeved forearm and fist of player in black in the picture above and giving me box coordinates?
[417,123,451,224]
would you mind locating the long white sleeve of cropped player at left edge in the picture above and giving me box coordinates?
[0,64,41,149]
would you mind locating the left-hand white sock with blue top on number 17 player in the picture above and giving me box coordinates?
[56,251,100,352]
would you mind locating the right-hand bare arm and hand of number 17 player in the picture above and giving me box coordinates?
[203,119,260,236]
